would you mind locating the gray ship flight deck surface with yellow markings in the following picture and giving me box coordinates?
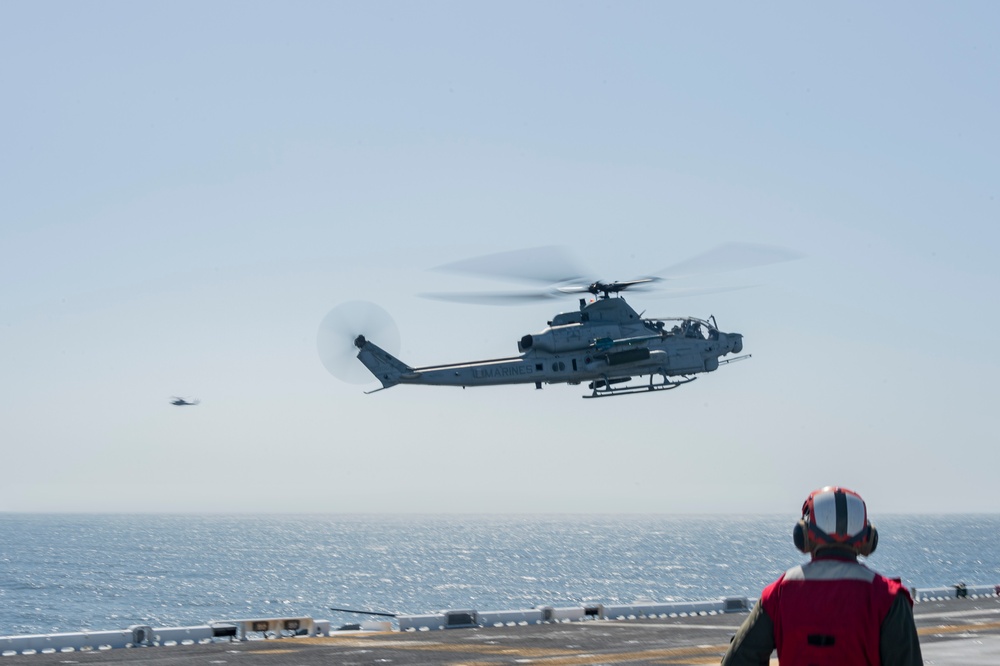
[7,597,1000,666]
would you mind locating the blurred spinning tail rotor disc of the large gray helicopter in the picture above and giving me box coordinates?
[316,301,399,384]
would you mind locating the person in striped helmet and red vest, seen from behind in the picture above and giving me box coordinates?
[722,486,923,666]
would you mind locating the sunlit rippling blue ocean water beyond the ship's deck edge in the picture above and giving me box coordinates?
[0,514,1000,635]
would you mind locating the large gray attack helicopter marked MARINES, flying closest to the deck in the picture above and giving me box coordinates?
[319,244,795,398]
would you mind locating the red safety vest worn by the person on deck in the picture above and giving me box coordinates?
[760,558,913,666]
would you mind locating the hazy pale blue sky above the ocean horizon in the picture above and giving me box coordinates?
[0,2,1000,517]
